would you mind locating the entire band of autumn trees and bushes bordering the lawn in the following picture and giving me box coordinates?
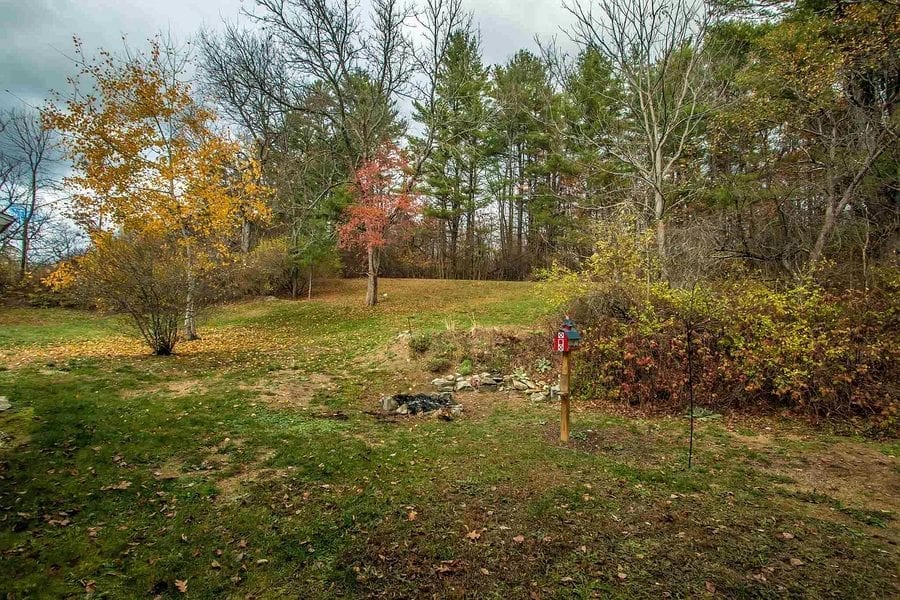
[0,0,900,428]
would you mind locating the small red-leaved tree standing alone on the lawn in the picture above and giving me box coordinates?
[339,143,421,306]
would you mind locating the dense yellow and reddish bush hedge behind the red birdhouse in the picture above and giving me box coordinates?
[545,223,900,435]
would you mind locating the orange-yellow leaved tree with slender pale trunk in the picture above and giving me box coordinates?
[44,38,268,350]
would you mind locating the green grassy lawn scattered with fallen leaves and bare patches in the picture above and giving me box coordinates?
[0,280,900,599]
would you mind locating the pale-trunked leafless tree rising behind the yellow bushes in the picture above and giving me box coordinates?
[565,0,712,274]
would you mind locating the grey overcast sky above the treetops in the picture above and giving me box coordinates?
[0,0,568,113]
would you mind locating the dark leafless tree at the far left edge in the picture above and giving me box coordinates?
[0,109,58,277]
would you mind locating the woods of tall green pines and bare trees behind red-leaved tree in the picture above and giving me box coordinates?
[193,0,900,291]
